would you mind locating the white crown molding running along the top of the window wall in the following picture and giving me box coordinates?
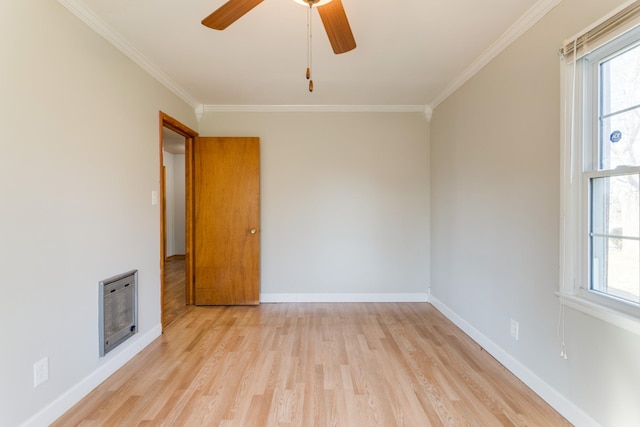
[429,0,562,110]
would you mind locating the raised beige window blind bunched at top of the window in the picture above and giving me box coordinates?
[560,0,640,59]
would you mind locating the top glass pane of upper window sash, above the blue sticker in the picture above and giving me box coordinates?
[600,42,640,116]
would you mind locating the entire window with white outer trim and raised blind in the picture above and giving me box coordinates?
[560,3,640,331]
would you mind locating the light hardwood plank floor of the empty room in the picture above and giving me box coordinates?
[53,303,570,427]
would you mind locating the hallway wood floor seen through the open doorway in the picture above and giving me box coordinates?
[162,255,189,328]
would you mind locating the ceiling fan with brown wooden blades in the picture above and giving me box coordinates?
[202,0,356,54]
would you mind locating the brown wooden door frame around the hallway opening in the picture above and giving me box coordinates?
[159,111,198,328]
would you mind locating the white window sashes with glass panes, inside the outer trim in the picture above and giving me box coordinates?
[581,36,640,304]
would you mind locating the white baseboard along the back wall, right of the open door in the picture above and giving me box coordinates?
[260,292,429,303]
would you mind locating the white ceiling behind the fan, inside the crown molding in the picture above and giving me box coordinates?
[59,0,560,108]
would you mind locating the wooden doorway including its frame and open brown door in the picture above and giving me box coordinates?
[160,112,260,320]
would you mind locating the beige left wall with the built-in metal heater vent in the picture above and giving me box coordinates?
[0,0,197,426]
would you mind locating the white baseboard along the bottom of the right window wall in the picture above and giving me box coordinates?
[430,296,601,427]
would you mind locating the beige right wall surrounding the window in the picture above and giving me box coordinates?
[431,0,640,426]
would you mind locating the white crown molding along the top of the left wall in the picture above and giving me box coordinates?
[58,0,200,110]
